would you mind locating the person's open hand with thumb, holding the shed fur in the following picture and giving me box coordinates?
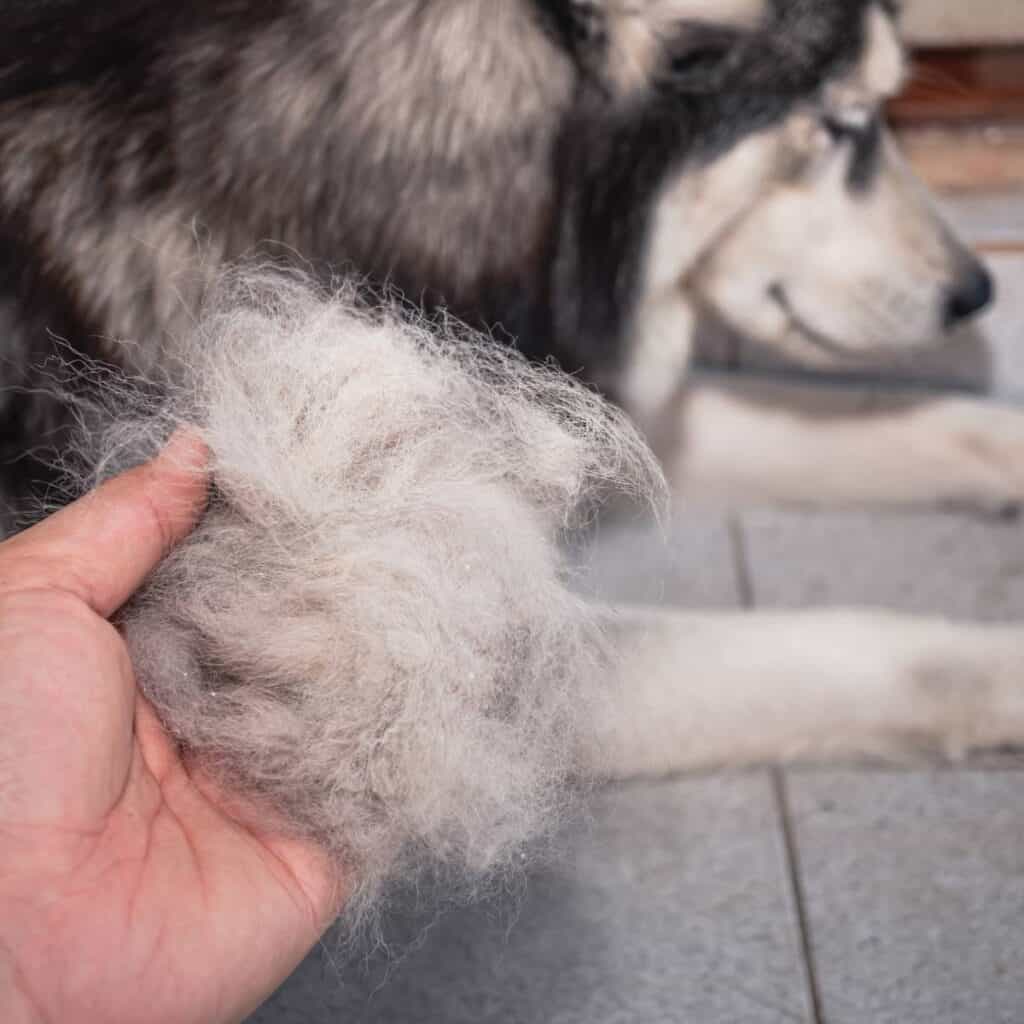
[0,434,343,1024]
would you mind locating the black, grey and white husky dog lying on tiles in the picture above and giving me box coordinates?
[6,0,1024,776]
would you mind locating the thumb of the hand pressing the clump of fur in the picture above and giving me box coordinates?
[0,430,208,615]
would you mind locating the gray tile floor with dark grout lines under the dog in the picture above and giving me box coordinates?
[250,200,1024,1024]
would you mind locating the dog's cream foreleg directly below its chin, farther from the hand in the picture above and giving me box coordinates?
[656,381,1024,512]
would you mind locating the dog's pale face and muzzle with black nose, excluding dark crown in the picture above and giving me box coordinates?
[678,4,992,354]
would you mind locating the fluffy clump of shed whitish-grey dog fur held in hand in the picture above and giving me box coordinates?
[61,274,657,927]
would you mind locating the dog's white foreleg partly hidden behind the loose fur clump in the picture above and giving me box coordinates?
[583,608,1024,778]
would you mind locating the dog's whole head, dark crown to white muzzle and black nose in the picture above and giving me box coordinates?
[563,0,992,368]
